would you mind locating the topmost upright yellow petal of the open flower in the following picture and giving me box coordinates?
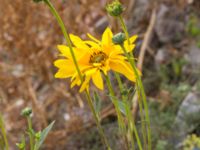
[101,27,113,45]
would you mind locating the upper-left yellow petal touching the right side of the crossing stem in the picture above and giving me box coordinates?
[69,34,89,50]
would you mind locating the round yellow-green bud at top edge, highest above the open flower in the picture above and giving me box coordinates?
[106,0,124,17]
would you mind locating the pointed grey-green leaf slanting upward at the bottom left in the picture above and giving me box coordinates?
[34,121,55,150]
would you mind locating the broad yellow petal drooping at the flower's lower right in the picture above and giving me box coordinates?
[110,60,136,82]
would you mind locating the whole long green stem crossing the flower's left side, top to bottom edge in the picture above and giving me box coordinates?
[44,0,111,150]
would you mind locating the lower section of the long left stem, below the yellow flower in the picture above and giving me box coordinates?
[85,90,111,150]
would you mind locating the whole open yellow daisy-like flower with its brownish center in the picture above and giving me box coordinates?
[54,28,137,92]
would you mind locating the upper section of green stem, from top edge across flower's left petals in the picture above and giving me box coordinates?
[44,0,83,81]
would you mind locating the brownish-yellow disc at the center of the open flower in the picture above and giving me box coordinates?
[90,51,108,64]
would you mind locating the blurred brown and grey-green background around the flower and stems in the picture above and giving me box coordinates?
[0,0,200,150]
